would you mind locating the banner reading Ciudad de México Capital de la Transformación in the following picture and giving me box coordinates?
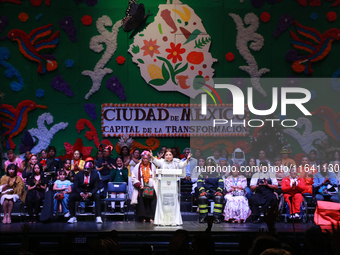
[101,104,249,137]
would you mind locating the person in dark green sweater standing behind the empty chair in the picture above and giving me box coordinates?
[111,156,129,213]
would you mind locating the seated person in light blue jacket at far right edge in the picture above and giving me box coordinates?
[313,163,339,203]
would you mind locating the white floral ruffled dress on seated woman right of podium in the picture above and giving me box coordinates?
[224,175,251,221]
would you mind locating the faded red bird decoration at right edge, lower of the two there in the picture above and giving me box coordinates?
[312,106,340,141]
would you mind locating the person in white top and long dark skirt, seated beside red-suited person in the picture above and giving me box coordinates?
[249,162,278,223]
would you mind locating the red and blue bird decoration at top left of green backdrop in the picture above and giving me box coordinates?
[8,24,59,74]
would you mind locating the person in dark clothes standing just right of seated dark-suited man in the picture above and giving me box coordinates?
[96,145,116,197]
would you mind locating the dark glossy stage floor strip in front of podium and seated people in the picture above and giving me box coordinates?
[0,221,315,234]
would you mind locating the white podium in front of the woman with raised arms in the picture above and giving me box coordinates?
[154,169,183,226]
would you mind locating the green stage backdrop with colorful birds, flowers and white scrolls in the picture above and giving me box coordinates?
[0,0,340,159]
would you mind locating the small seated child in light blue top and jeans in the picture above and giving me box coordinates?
[53,170,72,217]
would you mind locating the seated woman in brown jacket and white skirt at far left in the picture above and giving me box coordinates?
[0,164,26,224]
